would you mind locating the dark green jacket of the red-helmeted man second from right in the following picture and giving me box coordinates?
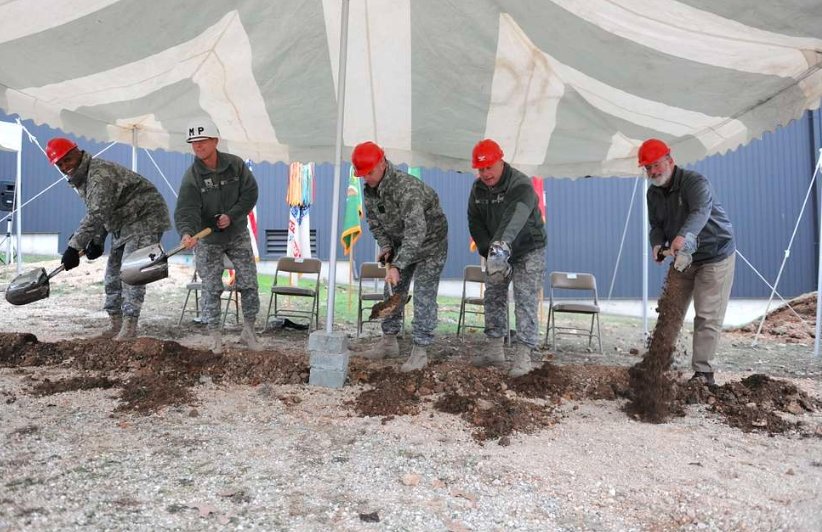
[468,163,548,260]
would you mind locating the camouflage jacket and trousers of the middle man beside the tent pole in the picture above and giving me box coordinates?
[363,161,448,346]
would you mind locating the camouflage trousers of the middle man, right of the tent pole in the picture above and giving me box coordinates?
[382,242,448,346]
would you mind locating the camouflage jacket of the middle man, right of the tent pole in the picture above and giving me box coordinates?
[363,162,448,269]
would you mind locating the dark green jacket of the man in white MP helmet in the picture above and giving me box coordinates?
[174,151,258,244]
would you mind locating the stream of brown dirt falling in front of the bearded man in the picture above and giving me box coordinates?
[625,268,689,423]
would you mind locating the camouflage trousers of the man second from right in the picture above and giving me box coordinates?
[484,247,545,349]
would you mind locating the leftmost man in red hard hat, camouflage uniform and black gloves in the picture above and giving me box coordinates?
[46,137,171,340]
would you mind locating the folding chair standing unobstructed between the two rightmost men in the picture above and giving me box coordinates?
[544,272,602,353]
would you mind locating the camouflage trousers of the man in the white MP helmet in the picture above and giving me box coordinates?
[194,231,260,329]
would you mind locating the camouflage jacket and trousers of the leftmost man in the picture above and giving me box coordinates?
[68,152,171,317]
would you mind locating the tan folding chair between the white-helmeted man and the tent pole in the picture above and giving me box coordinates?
[263,257,322,330]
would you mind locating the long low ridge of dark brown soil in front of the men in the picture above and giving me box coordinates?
[0,329,822,445]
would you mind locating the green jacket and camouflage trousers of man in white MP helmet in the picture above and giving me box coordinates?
[174,151,260,330]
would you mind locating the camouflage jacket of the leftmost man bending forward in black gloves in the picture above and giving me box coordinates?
[69,152,171,250]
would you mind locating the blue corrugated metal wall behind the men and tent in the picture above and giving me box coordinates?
[0,111,822,298]
